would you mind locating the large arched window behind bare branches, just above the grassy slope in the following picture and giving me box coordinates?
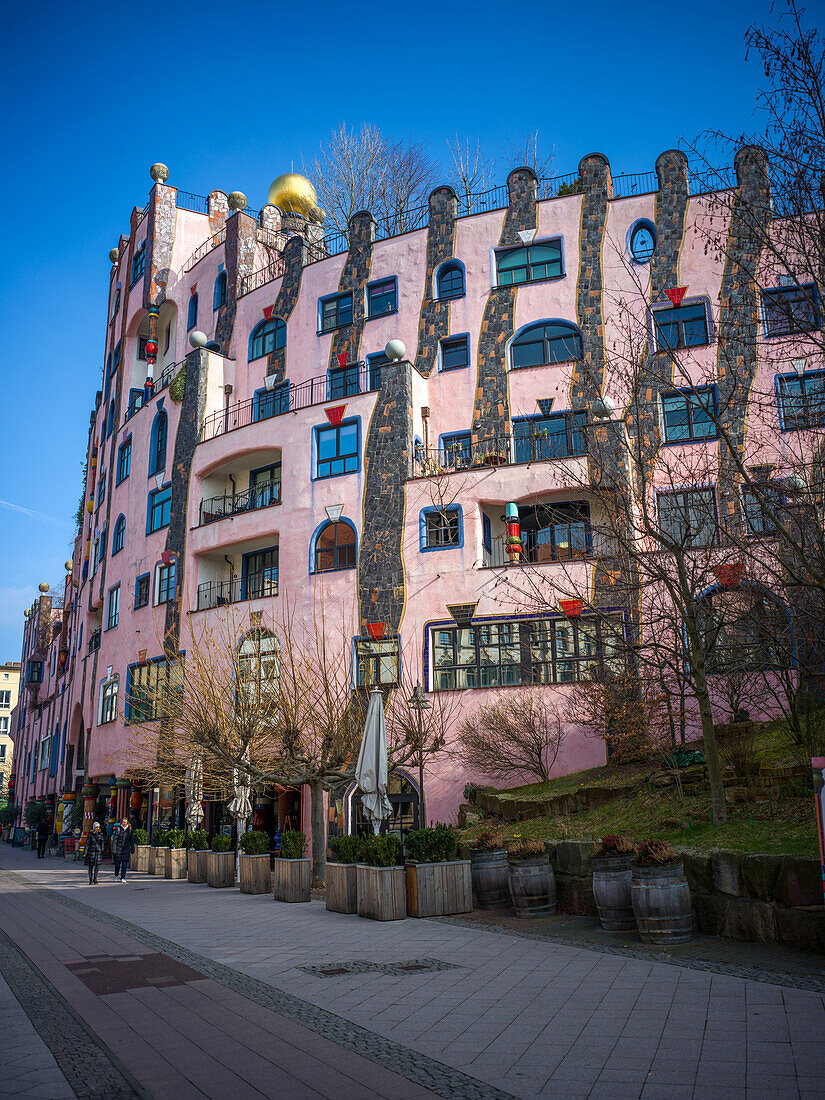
[696,585,793,672]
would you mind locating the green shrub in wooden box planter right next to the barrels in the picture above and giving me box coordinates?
[404,825,473,916]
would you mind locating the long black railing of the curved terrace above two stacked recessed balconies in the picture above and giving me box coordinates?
[200,363,382,443]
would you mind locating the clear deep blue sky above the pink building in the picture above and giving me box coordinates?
[0,0,770,660]
